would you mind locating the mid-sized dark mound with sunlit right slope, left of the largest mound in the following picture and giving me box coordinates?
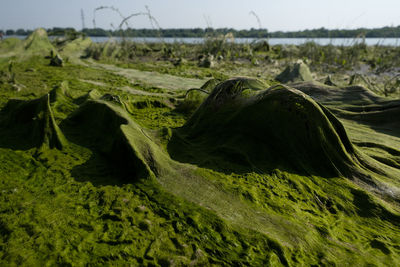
[62,100,164,180]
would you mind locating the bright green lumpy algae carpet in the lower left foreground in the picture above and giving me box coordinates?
[1,148,288,265]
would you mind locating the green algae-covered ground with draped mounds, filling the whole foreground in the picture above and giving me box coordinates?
[0,30,400,266]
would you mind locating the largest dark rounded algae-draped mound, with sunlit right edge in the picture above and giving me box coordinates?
[169,78,357,177]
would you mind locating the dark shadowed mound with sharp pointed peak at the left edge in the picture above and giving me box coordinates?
[0,94,67,149]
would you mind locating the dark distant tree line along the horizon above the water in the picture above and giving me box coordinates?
[0,26,400,38]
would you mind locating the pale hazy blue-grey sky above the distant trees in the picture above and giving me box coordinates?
[0,0,400,31]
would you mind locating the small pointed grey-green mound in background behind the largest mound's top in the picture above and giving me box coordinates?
[275,60,313,83]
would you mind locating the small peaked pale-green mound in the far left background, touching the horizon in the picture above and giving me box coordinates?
[23,28,55,53]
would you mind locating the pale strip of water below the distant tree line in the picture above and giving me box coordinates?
[5,36,400,46]
